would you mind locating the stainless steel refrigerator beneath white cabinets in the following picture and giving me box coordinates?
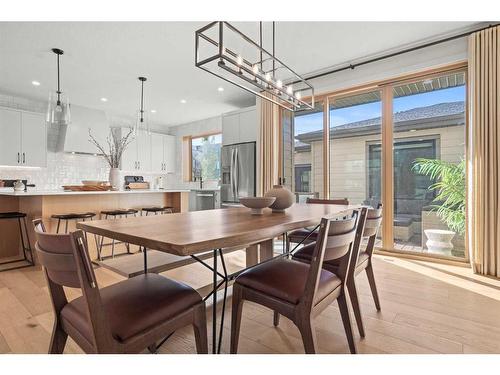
[221,142,255,205]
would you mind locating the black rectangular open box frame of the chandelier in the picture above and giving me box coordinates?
[195,21,314,112]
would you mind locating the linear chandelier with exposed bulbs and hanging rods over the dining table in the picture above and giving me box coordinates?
[195,21,314,112]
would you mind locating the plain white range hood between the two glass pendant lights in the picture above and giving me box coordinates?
[64,105,109,154]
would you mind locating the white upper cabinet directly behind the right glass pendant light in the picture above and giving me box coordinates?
[121,128,152,172]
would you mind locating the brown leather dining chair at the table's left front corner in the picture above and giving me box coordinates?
[34,219,208,353]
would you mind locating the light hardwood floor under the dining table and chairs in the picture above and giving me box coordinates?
[0,251,500,353]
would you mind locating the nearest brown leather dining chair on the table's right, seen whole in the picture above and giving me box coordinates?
[231,208,366,353]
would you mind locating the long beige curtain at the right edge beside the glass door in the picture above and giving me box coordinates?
[468,27,500,277]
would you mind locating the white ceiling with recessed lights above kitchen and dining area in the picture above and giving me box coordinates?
[0,22,473,126]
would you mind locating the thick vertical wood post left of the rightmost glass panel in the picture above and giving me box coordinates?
[381,86,394,249]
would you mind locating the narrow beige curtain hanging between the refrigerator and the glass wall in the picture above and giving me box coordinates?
[257,93,280,195]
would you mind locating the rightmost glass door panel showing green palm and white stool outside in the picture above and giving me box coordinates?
[392,71,466,258]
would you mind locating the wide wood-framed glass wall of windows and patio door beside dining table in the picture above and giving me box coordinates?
[283,63,467,260]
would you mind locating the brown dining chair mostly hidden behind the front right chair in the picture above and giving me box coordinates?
[292,204,382,337]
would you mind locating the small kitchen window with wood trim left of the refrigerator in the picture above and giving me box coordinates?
[185,133,222,181]
